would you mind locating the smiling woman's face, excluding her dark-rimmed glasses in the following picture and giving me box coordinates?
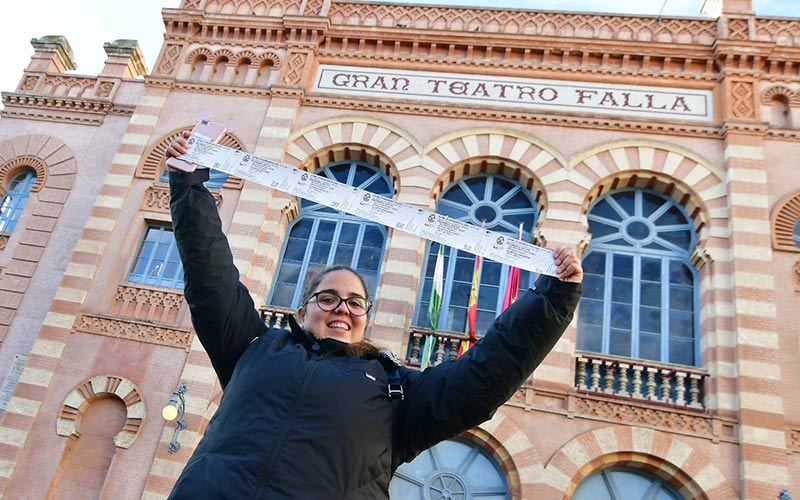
[297,269,367,343]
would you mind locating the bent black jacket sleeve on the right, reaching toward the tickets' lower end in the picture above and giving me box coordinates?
[394,276,581,463]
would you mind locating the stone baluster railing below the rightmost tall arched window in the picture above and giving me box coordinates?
[575,353,708,411]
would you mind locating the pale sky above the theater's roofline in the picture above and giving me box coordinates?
[0,0,800,105]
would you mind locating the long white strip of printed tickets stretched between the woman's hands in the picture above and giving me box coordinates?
[180,136,557,276]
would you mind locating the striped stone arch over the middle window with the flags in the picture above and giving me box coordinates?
[423,128,566,221]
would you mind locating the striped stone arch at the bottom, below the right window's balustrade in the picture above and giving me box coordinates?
[545,426,737,500]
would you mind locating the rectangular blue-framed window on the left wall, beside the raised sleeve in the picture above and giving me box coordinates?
[127,225,183,289]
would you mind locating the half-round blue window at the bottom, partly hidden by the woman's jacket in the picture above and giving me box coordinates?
[389,438,511,500]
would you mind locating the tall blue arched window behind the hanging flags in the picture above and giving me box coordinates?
[414,174,538,335]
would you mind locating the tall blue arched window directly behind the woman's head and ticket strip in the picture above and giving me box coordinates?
[269,160,394,308]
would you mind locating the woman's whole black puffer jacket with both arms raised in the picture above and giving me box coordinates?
[170,170,580,500]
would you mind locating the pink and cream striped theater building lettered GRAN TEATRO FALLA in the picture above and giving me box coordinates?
[0,0,800,500]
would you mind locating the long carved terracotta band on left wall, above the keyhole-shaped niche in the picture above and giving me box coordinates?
[75,314,194,351]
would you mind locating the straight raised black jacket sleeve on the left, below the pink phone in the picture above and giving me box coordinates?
[169,169,266,388]
